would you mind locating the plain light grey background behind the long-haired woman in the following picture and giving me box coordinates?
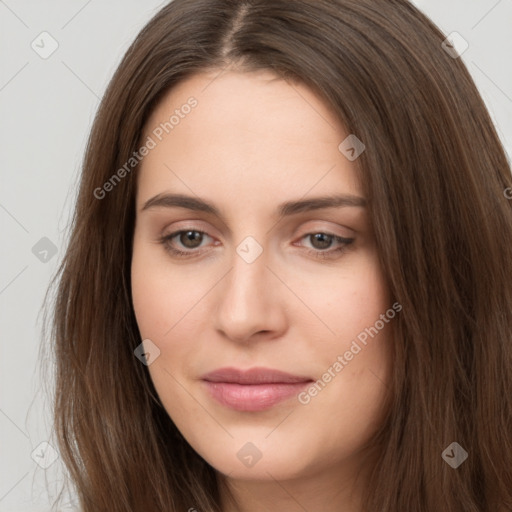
[0,0,512,512]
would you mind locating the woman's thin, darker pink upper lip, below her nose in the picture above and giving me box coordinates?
[202,367,312,384]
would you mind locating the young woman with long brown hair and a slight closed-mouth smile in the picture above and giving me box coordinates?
[44,0,512,512]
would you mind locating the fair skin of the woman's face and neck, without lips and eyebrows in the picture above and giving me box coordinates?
[132,71,392,512]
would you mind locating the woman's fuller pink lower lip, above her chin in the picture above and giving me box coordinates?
[203,381,311,411]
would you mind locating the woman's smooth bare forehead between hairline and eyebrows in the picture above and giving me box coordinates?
[134,70,361,209]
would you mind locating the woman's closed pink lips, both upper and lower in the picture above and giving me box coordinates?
[202,368,313,411]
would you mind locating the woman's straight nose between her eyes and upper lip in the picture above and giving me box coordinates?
[215,241,289,342]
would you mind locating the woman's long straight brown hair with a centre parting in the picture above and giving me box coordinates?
[44,0,512,512]
